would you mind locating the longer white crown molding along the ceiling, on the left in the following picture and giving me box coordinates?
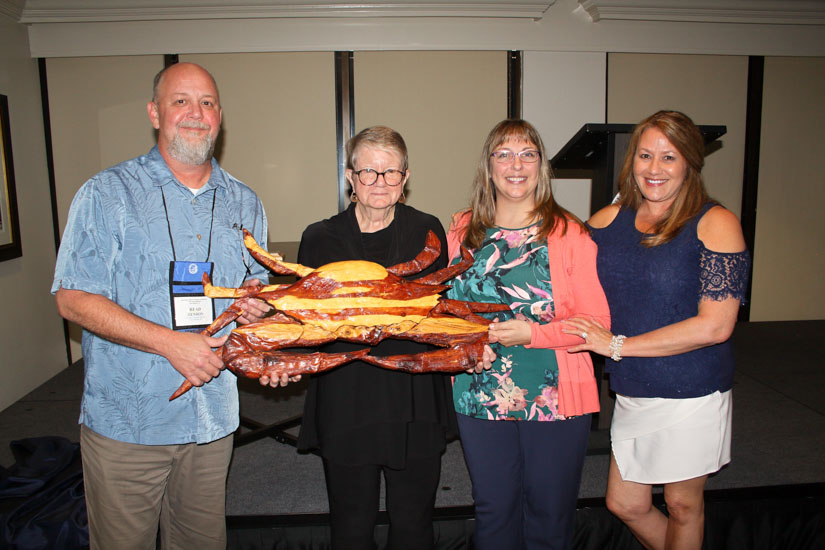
[17,0,556,23]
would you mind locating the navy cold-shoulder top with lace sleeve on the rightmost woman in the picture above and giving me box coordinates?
[592,203,750,398]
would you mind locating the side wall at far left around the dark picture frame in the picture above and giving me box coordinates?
[0,15,67,410]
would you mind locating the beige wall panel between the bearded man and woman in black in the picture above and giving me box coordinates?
[180,52,338,244]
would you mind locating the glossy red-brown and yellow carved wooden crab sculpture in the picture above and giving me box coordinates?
[169,230,509,400]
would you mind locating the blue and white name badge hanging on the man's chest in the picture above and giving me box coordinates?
[169,261,215,332]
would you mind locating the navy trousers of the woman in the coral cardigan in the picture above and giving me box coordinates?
[457,414,590,550]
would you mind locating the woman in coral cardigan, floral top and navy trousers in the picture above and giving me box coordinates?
[447,120,610,550]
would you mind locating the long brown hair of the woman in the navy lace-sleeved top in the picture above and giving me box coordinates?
[618,111,712,247]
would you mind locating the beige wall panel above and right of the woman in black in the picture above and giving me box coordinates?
[354,51,507,229]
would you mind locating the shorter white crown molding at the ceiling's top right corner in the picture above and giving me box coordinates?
[578,0,825,25]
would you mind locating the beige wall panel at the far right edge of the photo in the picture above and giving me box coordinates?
[751,57,825,321]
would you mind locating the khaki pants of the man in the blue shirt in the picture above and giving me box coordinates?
[80,425,232,550]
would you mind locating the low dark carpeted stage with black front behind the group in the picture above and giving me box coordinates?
[0,321,825,549]
